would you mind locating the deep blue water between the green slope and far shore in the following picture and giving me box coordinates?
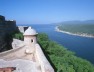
[23,24,94,64]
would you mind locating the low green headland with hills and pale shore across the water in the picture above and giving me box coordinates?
[57,20,94,38]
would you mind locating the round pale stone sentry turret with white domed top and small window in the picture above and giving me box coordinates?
[24,27,38,46]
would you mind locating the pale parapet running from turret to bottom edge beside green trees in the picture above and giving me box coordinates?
[35,44,54,72]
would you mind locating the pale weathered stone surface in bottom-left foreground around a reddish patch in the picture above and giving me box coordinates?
[0,59,38,72]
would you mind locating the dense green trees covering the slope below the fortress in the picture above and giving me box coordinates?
[38,34,94,72]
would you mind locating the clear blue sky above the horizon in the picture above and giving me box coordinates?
[0,0,94,24]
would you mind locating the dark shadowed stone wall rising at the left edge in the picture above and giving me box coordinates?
[0,15,17,52]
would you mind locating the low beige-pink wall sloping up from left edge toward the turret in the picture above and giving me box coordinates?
[0,45,26,60]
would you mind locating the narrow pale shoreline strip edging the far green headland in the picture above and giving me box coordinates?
[55,26,94,38]
